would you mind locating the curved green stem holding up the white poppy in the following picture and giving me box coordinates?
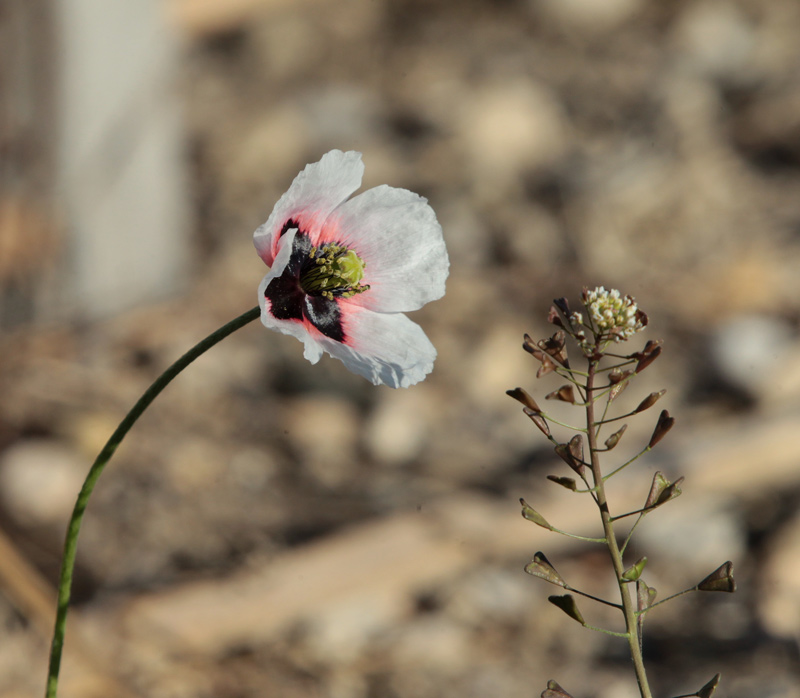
[45,306,261,698]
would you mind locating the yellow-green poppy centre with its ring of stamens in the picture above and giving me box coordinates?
[300,242,369,300]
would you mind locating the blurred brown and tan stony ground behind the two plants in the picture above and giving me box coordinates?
[0,0,800,698]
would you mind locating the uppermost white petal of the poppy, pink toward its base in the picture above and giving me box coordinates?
[253,150,364,266]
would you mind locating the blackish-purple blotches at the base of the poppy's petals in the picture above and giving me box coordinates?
[264,219,345,342]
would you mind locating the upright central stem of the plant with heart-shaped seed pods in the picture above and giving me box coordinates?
[586,359,653,698]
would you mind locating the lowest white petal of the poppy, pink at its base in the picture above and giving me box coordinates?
[319,304,436,388]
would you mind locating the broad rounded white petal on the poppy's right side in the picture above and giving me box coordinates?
[326,185,450,312]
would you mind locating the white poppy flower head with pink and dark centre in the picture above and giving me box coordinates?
[253,150,450,388]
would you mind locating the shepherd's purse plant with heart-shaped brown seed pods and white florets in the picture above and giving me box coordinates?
[507,287,736,698]
